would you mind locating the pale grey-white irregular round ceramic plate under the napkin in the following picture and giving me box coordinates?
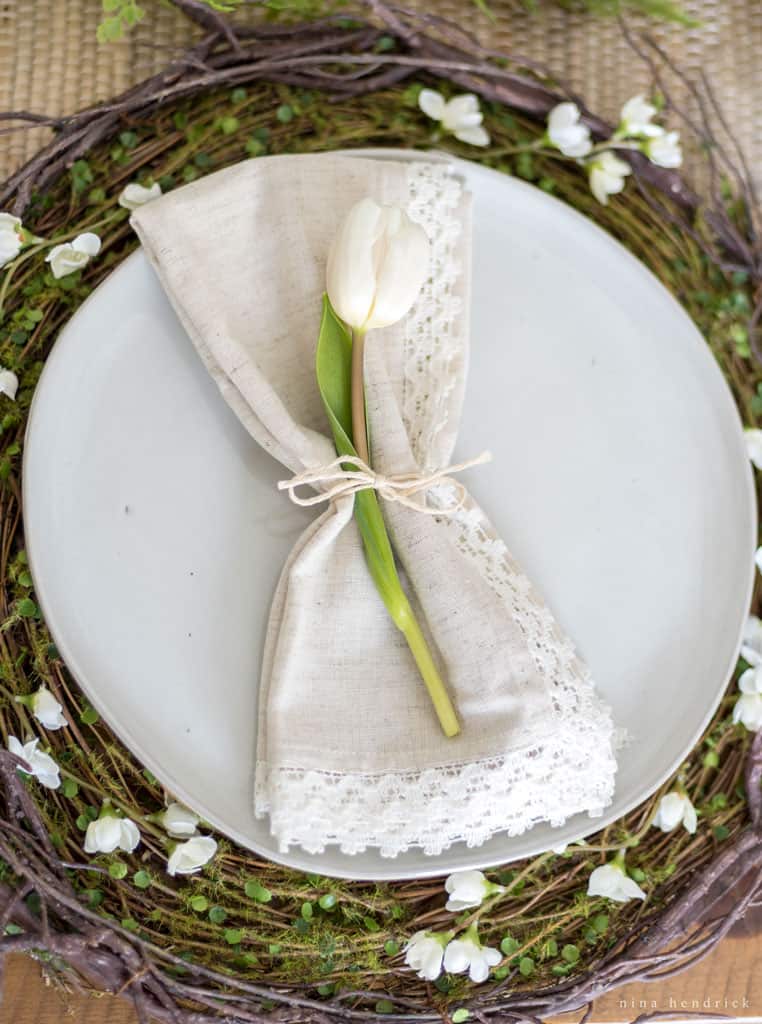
[24,151,756,879]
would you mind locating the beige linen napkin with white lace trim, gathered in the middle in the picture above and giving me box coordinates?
[132,154,617,856]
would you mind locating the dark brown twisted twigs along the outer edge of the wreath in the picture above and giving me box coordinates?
[0,0,762,1024]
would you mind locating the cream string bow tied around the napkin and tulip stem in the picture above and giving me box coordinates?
[278,452,492,516]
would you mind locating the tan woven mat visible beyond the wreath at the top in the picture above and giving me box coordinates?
[0,0,762,178]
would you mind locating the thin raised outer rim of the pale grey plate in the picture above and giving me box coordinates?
[22,147,758,882]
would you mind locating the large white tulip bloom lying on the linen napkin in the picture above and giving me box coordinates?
[326,198,430,333]
